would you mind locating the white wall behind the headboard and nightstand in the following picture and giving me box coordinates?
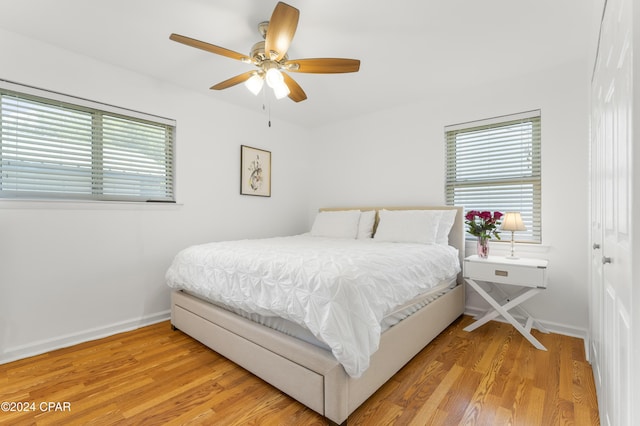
[309,58,588,336]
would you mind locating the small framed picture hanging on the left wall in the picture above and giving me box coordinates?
[240,145,271,197]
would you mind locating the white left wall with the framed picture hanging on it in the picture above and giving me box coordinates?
[0,30,309,362]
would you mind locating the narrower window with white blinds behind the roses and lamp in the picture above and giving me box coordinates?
[445,110,542,243]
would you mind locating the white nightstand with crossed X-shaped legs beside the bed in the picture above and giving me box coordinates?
[463,256,549,351]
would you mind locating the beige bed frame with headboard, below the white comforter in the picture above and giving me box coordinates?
[171,206,465,424]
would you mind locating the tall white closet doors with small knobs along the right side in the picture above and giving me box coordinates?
[590,0,638,426]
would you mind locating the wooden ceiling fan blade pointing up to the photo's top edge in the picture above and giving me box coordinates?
[264,2,300,61]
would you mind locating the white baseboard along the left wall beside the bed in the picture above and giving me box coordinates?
[0,310,171,364]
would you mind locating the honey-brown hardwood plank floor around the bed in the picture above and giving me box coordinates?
[0,316,599,426]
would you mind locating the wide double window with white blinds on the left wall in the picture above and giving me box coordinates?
[0,82,175,201]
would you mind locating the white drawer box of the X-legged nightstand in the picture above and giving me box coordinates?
[464,261,547,288]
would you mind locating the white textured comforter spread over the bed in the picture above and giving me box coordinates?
[166,234,460,377]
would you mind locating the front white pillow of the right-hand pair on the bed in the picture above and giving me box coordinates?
[374,210,442,244]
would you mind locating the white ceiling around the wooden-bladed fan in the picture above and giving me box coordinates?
[0,0,590,126]
